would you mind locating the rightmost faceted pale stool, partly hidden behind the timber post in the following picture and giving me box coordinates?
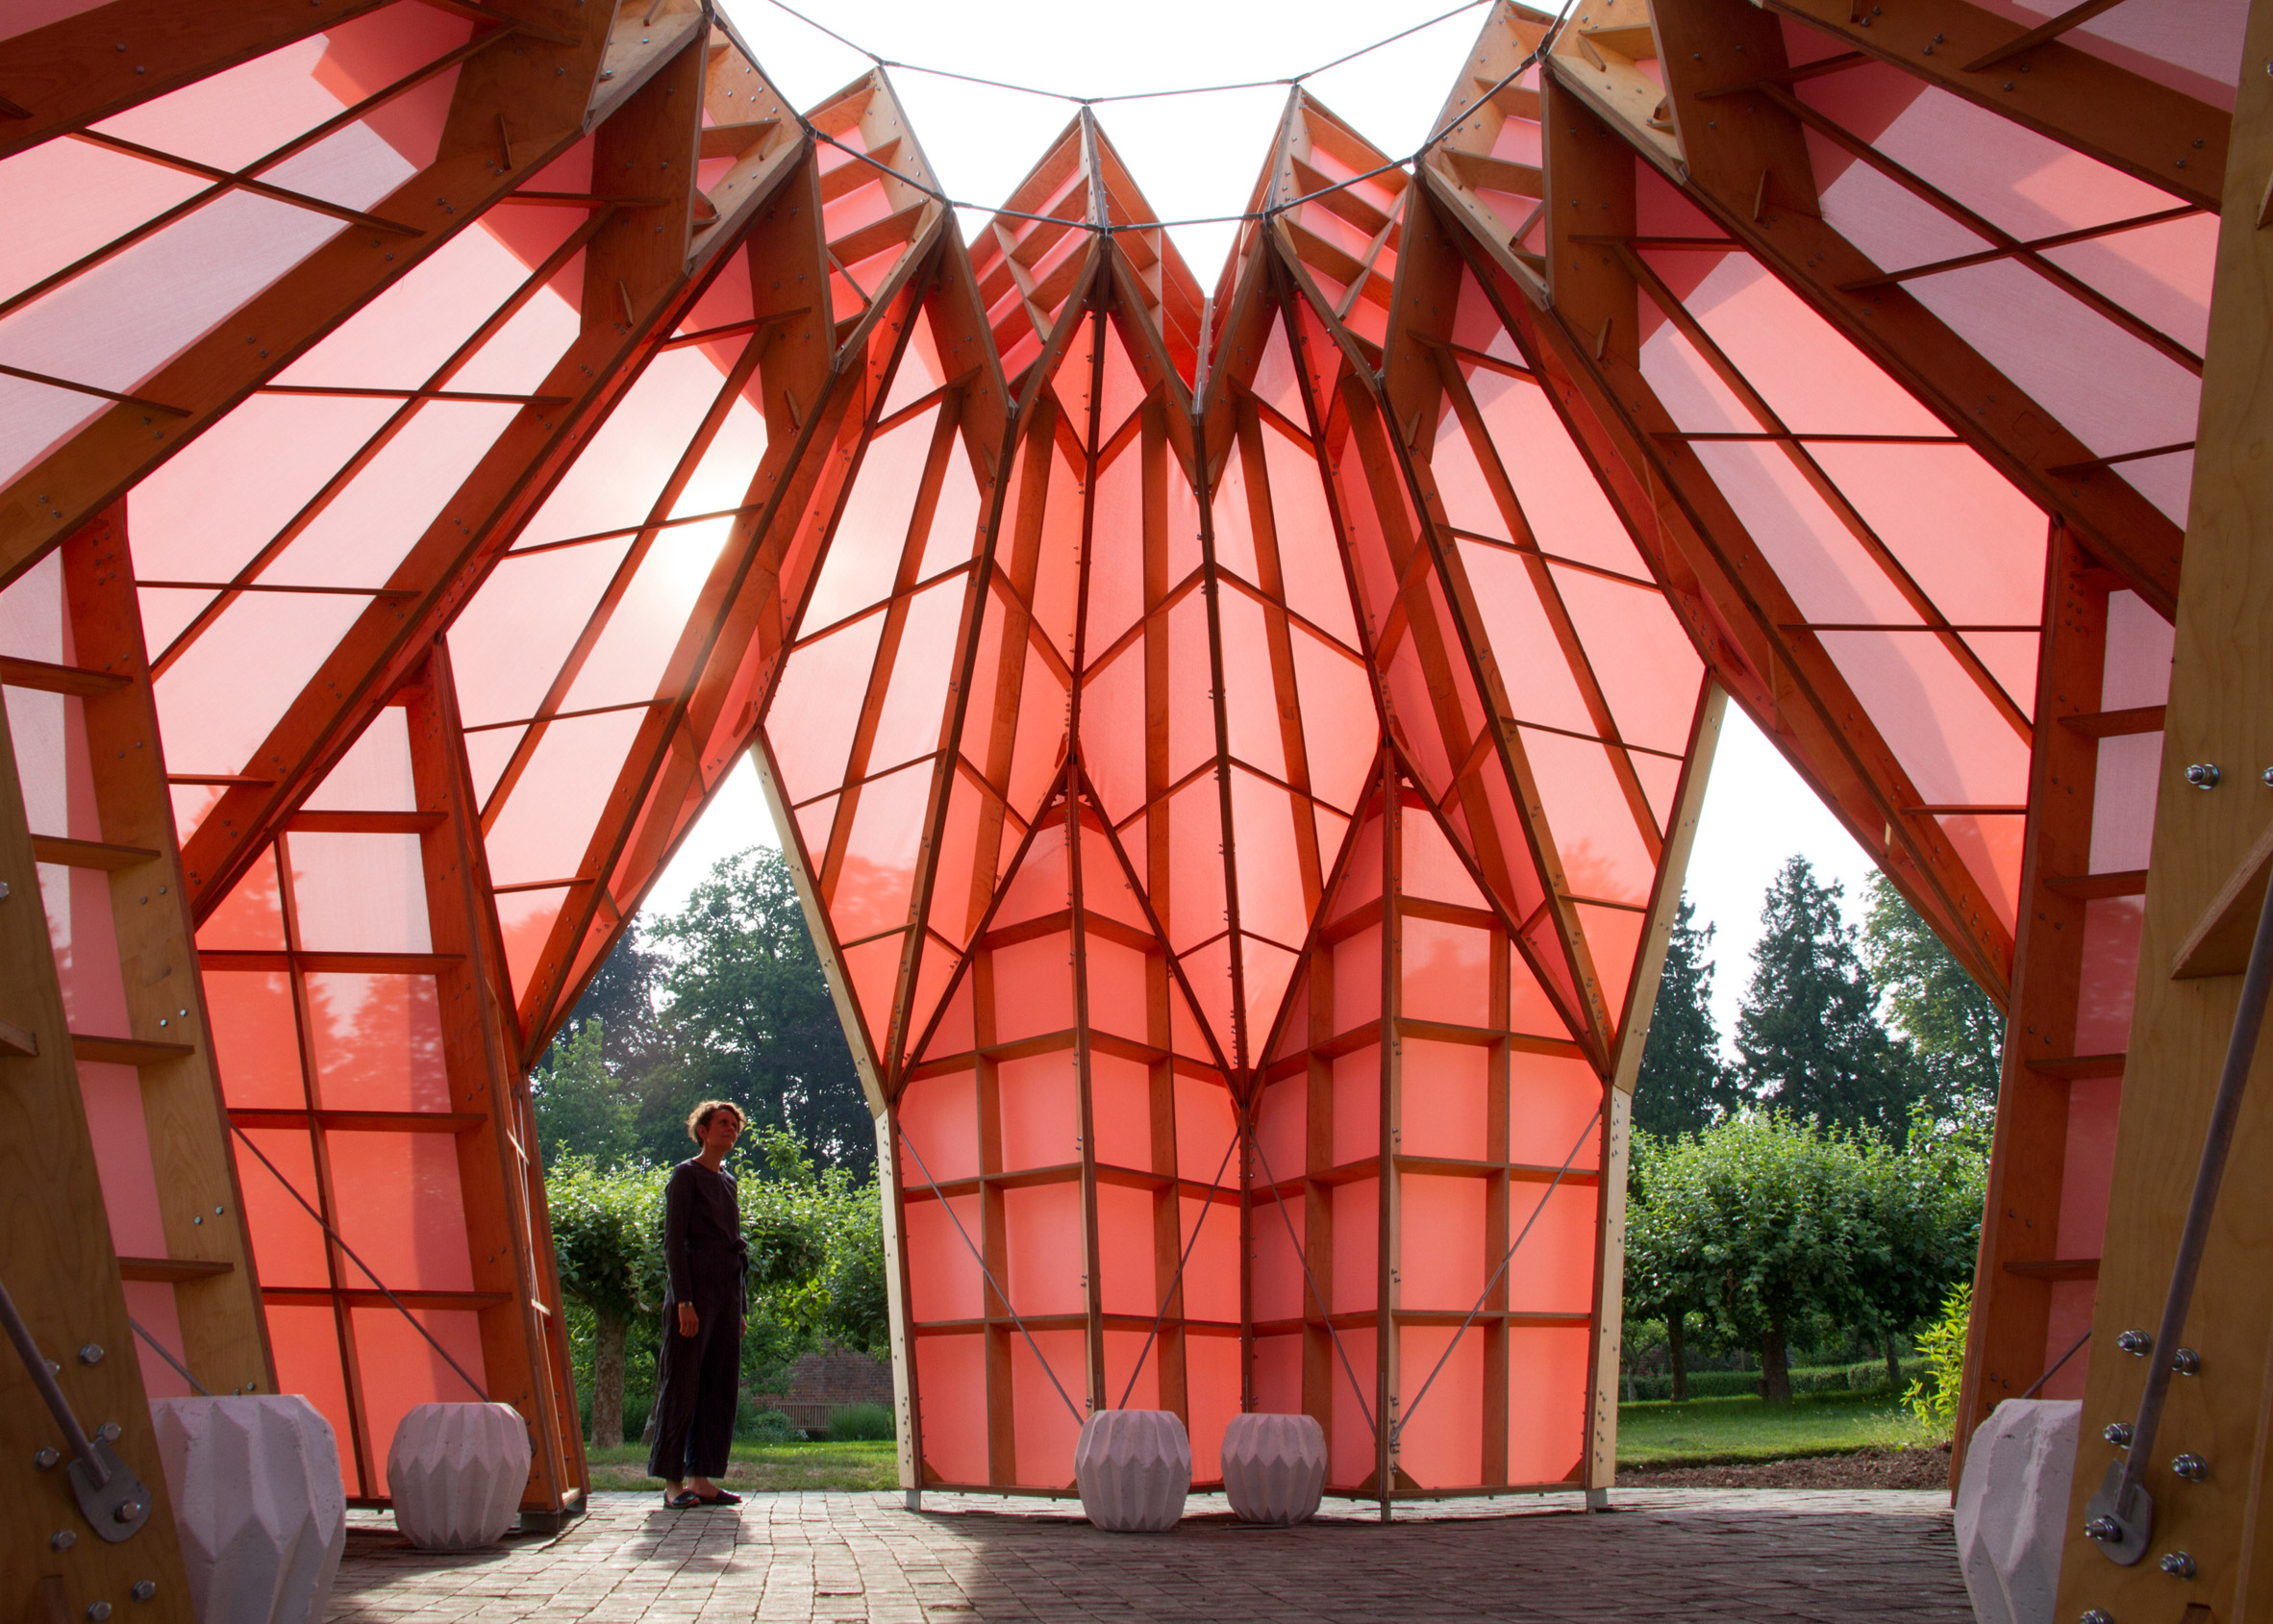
[1957,1399,2085,1624]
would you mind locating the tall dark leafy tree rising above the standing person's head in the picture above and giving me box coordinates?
[641,846,875,1174]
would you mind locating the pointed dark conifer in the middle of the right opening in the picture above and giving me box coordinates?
[1736,858,1916,1139]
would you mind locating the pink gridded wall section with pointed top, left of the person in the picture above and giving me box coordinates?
[198,705,484,1499]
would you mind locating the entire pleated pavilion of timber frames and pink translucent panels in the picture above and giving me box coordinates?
[0,0,2273,1617]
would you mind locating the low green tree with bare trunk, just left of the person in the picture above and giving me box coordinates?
[545,1156,670,1446]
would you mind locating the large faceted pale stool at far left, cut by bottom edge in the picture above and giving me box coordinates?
[150,1392,348,1624]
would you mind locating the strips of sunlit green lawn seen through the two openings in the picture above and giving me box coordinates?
[591,1392,1938,1489]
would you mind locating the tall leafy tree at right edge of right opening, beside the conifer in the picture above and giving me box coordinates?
[1861,873,2005,1131]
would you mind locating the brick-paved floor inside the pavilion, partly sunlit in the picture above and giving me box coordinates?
[327,1489,1973,1624]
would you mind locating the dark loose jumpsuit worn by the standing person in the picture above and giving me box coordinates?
[648,1160,748,1483]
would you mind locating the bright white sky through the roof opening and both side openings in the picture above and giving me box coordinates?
[645,0,1871,1050]
